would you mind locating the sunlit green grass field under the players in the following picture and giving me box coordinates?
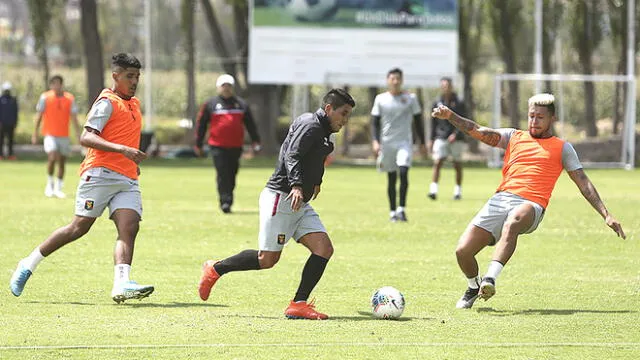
[0,160,640,360]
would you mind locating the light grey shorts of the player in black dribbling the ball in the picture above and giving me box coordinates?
[258,188,327,251]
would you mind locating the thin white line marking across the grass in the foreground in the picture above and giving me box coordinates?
[0,342,640,351]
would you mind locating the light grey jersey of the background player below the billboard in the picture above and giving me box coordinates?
[371,91,422,144]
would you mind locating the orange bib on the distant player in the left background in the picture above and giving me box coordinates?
[42,90,74,137]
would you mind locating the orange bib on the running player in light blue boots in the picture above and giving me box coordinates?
[80,89,142,180]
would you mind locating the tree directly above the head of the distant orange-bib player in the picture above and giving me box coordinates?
[27,0,57,89]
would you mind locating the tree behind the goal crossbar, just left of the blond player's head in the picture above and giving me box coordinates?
[487,0,524,128]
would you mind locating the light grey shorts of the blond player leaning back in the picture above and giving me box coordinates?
[471,191,544,245]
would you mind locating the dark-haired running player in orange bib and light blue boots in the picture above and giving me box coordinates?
[10,53,154,303]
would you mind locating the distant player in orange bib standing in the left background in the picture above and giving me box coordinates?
[31,75,81,198]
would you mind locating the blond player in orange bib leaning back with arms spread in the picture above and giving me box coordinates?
[432,94,626,309]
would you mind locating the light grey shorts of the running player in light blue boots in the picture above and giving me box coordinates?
[76,167,142,219]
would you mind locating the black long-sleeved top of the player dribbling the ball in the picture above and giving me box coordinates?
[267,109,333,202]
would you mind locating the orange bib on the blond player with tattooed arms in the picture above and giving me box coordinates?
[497,130,564,208]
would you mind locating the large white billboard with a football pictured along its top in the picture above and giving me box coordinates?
[249,0,458,86]
